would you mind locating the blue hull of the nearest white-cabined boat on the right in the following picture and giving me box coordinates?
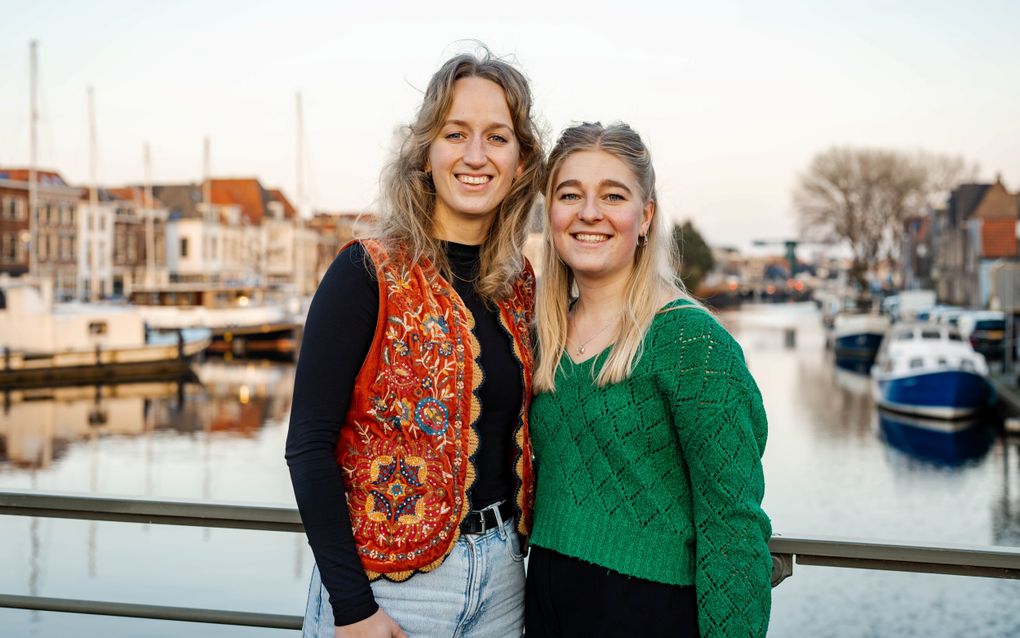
[875,370,992,419]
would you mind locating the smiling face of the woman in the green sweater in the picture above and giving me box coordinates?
[549,151,655,284]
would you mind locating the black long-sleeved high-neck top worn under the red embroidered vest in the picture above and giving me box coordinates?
[287,243,524,625]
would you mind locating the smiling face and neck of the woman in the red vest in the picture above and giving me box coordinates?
[425,78,523,244]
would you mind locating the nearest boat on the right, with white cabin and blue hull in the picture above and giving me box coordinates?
[871,324,995,419]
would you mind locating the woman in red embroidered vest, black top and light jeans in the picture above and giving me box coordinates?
[287,51,543,638]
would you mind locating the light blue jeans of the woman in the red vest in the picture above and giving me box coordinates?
[301,521,524,638]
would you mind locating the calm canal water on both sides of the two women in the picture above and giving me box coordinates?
[0,305,1020,638]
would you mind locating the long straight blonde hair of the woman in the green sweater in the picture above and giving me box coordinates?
[534,122,694,392]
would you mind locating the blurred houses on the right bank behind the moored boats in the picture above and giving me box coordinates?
[902,172,1020,308]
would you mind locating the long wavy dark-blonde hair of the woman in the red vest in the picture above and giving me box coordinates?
[375,47,543,300]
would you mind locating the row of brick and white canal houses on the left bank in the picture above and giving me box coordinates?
[0,167,370,300]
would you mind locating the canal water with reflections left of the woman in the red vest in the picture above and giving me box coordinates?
[0,360,299,638]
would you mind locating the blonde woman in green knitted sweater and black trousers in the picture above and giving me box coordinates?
[525,124,771,638]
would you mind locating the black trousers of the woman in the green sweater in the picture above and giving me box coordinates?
[524,545,699,638]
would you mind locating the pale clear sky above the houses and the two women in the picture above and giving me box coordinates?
[0,0,1020,254]
